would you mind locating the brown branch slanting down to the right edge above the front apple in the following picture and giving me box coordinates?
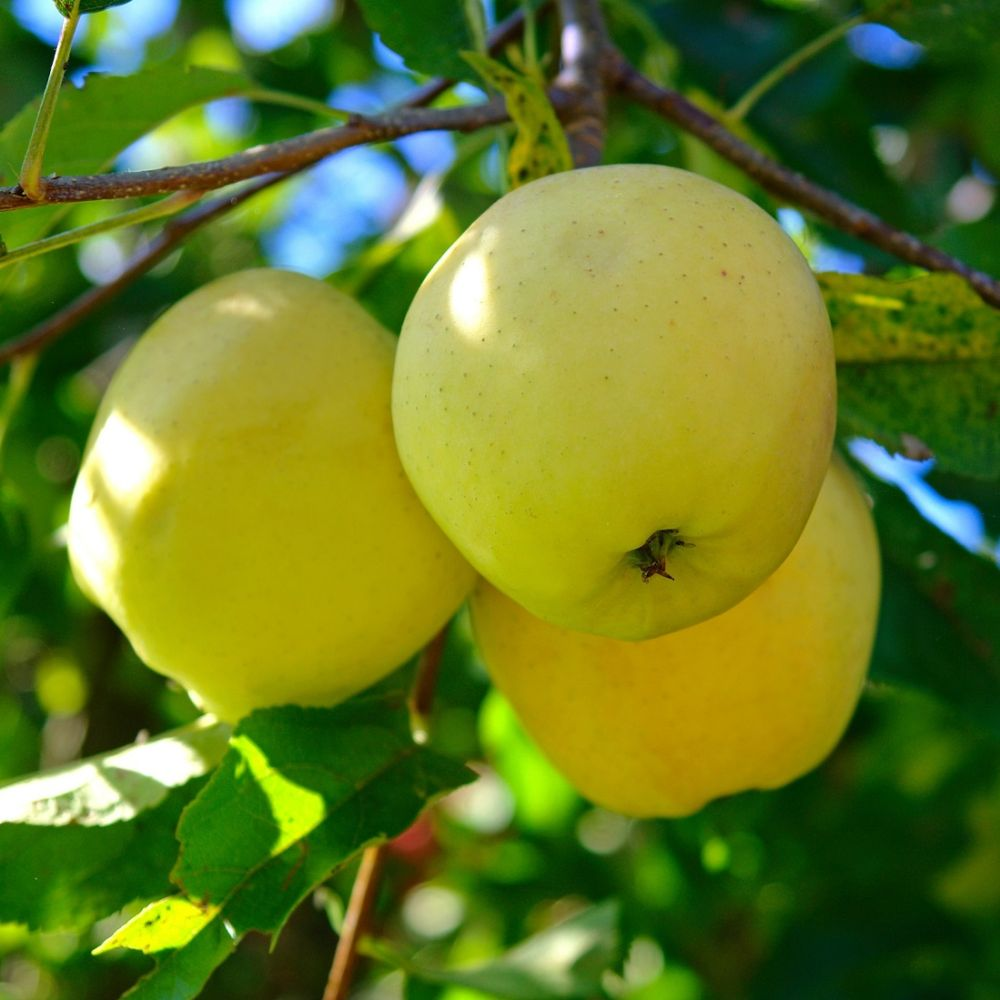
[609,52,1000,308]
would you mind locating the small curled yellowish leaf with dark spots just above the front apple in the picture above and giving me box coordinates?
[462,52,573,188]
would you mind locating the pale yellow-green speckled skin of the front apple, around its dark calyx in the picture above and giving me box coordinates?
[393,165,836,639]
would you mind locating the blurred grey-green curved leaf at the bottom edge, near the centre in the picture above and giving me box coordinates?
[372,902,620,1000]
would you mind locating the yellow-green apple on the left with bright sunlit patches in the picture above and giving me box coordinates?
[68,270,475,719]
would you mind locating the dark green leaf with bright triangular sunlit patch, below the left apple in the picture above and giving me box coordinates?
[174,693,473,931]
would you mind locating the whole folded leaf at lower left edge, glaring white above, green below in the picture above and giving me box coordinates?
[0,721,226,930]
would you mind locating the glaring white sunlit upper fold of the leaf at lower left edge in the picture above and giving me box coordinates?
[0,718,229,827]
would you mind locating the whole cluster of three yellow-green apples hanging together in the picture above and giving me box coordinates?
[68,165,879,816]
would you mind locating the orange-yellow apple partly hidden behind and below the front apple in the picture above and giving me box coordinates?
[470,462,880,817]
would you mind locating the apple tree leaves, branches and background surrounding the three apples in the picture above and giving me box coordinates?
[0,0,1000,1000]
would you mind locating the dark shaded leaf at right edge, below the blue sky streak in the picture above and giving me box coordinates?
[870,472,1000,735]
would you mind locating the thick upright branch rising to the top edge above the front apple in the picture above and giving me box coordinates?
[556,0,608,167]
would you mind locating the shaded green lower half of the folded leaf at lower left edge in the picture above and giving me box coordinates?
[0,778,205,930]
